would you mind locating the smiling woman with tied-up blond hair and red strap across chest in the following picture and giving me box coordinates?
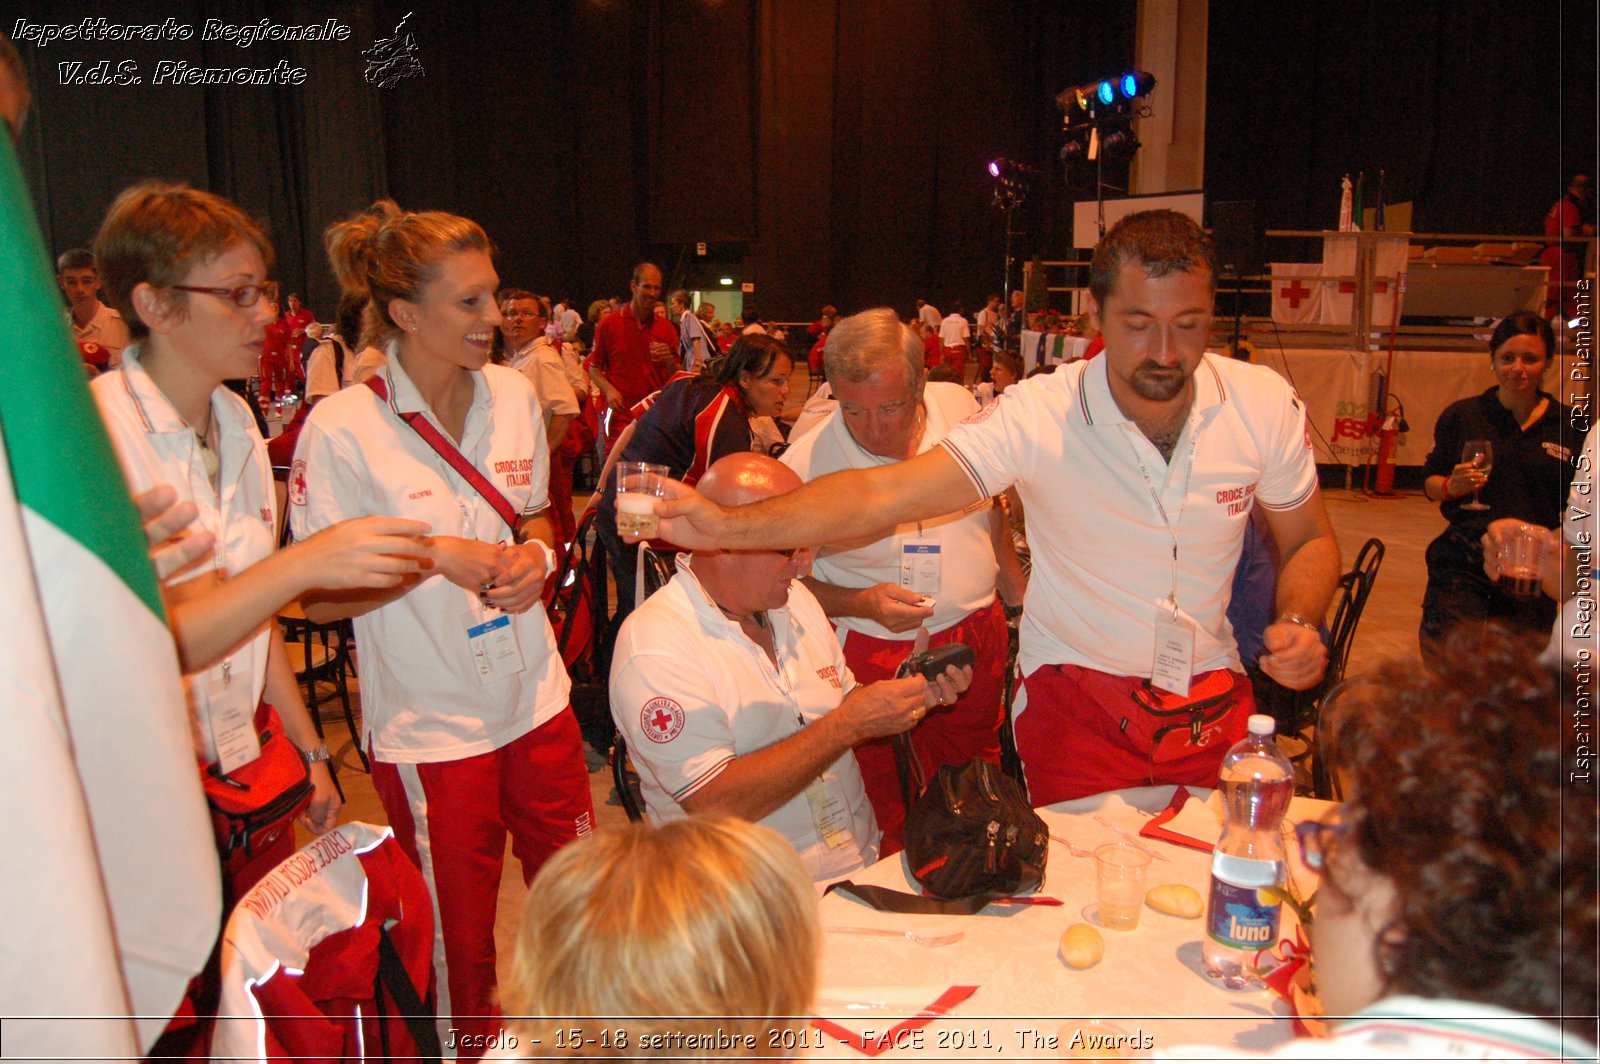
[290,200,594,1056]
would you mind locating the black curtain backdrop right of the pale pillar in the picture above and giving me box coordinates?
[1205,0,1597,258]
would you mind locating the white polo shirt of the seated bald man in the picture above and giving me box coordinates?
[611,557,880,883]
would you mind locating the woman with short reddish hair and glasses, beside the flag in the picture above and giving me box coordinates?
[93,182,426,898]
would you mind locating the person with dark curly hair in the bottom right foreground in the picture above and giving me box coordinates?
[1174,634,1600,1059]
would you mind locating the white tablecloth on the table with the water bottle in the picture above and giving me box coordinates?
[810,786,1328,1062]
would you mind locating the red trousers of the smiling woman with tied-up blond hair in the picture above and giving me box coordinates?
[373,709,594,1058]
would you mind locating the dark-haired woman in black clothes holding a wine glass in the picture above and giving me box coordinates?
[1421,314,1581,651]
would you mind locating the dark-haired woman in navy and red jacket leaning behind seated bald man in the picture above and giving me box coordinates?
[597,333,795,624]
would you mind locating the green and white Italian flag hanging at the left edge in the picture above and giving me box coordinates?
[0,136,221,1059]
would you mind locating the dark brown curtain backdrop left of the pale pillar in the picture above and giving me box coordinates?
[3,0,1134,318]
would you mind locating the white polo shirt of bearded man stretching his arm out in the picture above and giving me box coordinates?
[944,355,1317,677]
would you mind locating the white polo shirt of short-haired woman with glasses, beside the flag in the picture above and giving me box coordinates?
[90,344,278,763]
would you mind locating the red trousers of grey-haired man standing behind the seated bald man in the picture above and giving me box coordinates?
[845,598,1006,858]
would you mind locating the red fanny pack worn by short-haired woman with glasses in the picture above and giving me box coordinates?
[200,702,310,872]
